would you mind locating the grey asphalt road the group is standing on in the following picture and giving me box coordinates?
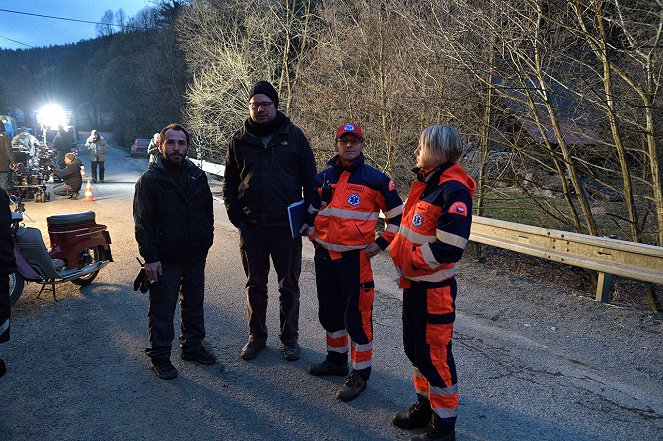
[0,145,663,441]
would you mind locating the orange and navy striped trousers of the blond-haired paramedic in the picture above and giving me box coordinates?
[403,278,458,426]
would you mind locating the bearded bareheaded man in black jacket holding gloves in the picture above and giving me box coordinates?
[134,124,216,380]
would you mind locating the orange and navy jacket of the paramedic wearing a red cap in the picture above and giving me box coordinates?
[309,154,403,251]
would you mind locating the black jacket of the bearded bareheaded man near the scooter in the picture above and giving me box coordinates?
[134,156,214,263]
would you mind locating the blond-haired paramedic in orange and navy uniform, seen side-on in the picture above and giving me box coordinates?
[390,126,476,441]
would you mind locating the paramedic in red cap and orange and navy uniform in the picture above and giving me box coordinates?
[308,123,403,401]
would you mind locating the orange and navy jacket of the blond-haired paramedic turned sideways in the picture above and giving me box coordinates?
[389,163,476,288]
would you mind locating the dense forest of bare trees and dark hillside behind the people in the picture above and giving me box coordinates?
[0,0,663,245]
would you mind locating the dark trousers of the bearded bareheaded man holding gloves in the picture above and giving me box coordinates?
[145,257,206,358]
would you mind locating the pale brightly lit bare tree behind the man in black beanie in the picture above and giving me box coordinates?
[178,0,312,159]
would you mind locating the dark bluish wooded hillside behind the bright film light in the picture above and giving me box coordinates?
[0,2,189,145]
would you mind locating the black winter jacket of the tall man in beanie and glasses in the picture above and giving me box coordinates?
[223,117,316,227]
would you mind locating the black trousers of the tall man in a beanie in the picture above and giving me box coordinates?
[240,223,302,344]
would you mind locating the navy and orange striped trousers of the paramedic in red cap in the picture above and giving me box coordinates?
[315,246,374,379]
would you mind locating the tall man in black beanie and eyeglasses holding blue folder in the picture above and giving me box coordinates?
[223,81,316,361]
